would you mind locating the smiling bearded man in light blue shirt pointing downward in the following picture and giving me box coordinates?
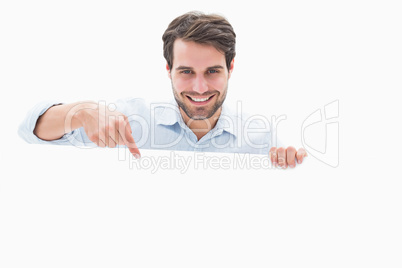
[19,12,307,168]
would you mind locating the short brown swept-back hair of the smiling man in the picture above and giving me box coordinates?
[162,11,236,70]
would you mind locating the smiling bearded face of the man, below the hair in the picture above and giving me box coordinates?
[166,39,233,120]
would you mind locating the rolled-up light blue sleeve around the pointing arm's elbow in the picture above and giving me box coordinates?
[18,101,96,147]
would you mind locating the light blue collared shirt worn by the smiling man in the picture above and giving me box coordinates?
[18,98,277,154]
